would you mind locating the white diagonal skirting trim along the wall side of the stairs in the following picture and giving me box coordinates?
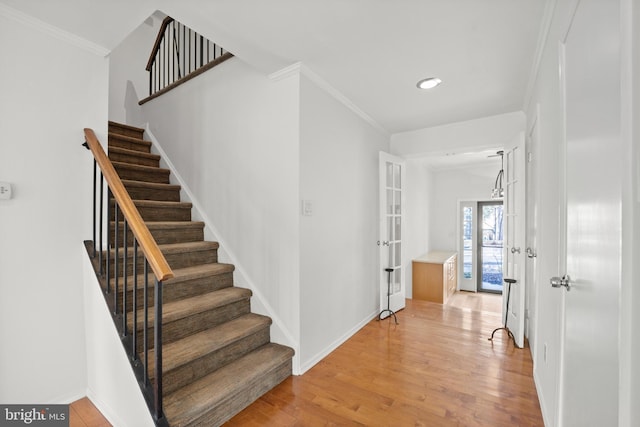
[145,123,300,375]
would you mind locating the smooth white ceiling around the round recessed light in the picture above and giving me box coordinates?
[0,0,546,134]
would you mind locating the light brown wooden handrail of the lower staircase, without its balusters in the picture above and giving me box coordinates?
[84,128,174,281]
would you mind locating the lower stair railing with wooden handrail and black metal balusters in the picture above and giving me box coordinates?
[82,129,173,426]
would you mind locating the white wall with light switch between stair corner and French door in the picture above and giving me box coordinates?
[300,75,389,371]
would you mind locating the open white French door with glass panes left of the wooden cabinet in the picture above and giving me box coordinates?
[378,152,405,319]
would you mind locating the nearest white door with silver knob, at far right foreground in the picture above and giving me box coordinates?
[555,0,622,426]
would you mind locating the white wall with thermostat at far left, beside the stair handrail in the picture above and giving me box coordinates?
[0,8,108,403]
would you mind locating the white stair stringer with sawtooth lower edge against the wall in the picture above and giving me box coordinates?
[144,122,302,375]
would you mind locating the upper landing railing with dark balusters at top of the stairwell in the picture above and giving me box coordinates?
[140,16,233,104]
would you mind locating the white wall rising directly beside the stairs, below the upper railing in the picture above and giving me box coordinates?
[133,58,299,366]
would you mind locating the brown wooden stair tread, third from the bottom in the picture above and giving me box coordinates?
[137,287,251,329]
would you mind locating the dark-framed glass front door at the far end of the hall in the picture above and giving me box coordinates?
[477,201,504,293]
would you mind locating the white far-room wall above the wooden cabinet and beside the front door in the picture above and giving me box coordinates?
[429,164,500,251]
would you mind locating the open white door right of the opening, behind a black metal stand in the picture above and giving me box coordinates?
[502,133,526,348]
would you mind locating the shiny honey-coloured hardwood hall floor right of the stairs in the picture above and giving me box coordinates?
[226,295,543,427]
